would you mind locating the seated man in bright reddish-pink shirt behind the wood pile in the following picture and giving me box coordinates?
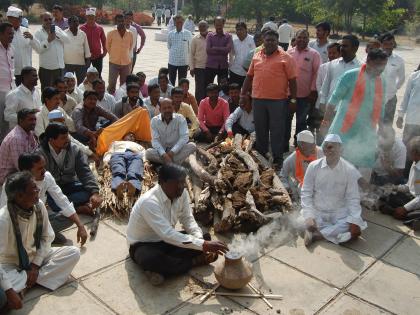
[194,83,230,143]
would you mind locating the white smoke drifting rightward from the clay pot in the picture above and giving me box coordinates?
[229,211,304,261]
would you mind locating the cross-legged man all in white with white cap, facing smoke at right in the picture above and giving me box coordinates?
[301,134,367,246]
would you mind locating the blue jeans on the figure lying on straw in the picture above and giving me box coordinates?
[109,151,143,192]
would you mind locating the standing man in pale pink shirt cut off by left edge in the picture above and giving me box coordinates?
[0,23,15,142]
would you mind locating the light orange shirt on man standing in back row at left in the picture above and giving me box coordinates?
[106,29,134,66]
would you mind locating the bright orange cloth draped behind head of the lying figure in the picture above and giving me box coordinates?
[96,107,152,155]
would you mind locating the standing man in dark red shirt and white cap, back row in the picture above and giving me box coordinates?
[80,8,107,77]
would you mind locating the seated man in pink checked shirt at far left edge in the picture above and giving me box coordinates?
[0,108,38,185]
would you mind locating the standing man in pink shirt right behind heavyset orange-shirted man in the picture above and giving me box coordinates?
[284,30,321,152]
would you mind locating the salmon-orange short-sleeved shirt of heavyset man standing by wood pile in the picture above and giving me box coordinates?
[247,48,296,100]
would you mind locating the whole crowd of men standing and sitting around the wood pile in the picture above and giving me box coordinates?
[0,5,420,309]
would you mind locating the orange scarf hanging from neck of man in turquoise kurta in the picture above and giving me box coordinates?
[341,64,383,133]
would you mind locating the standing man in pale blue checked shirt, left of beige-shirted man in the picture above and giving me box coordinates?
[168,15,192,86]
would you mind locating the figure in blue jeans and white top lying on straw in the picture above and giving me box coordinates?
[104,132,144,199]
